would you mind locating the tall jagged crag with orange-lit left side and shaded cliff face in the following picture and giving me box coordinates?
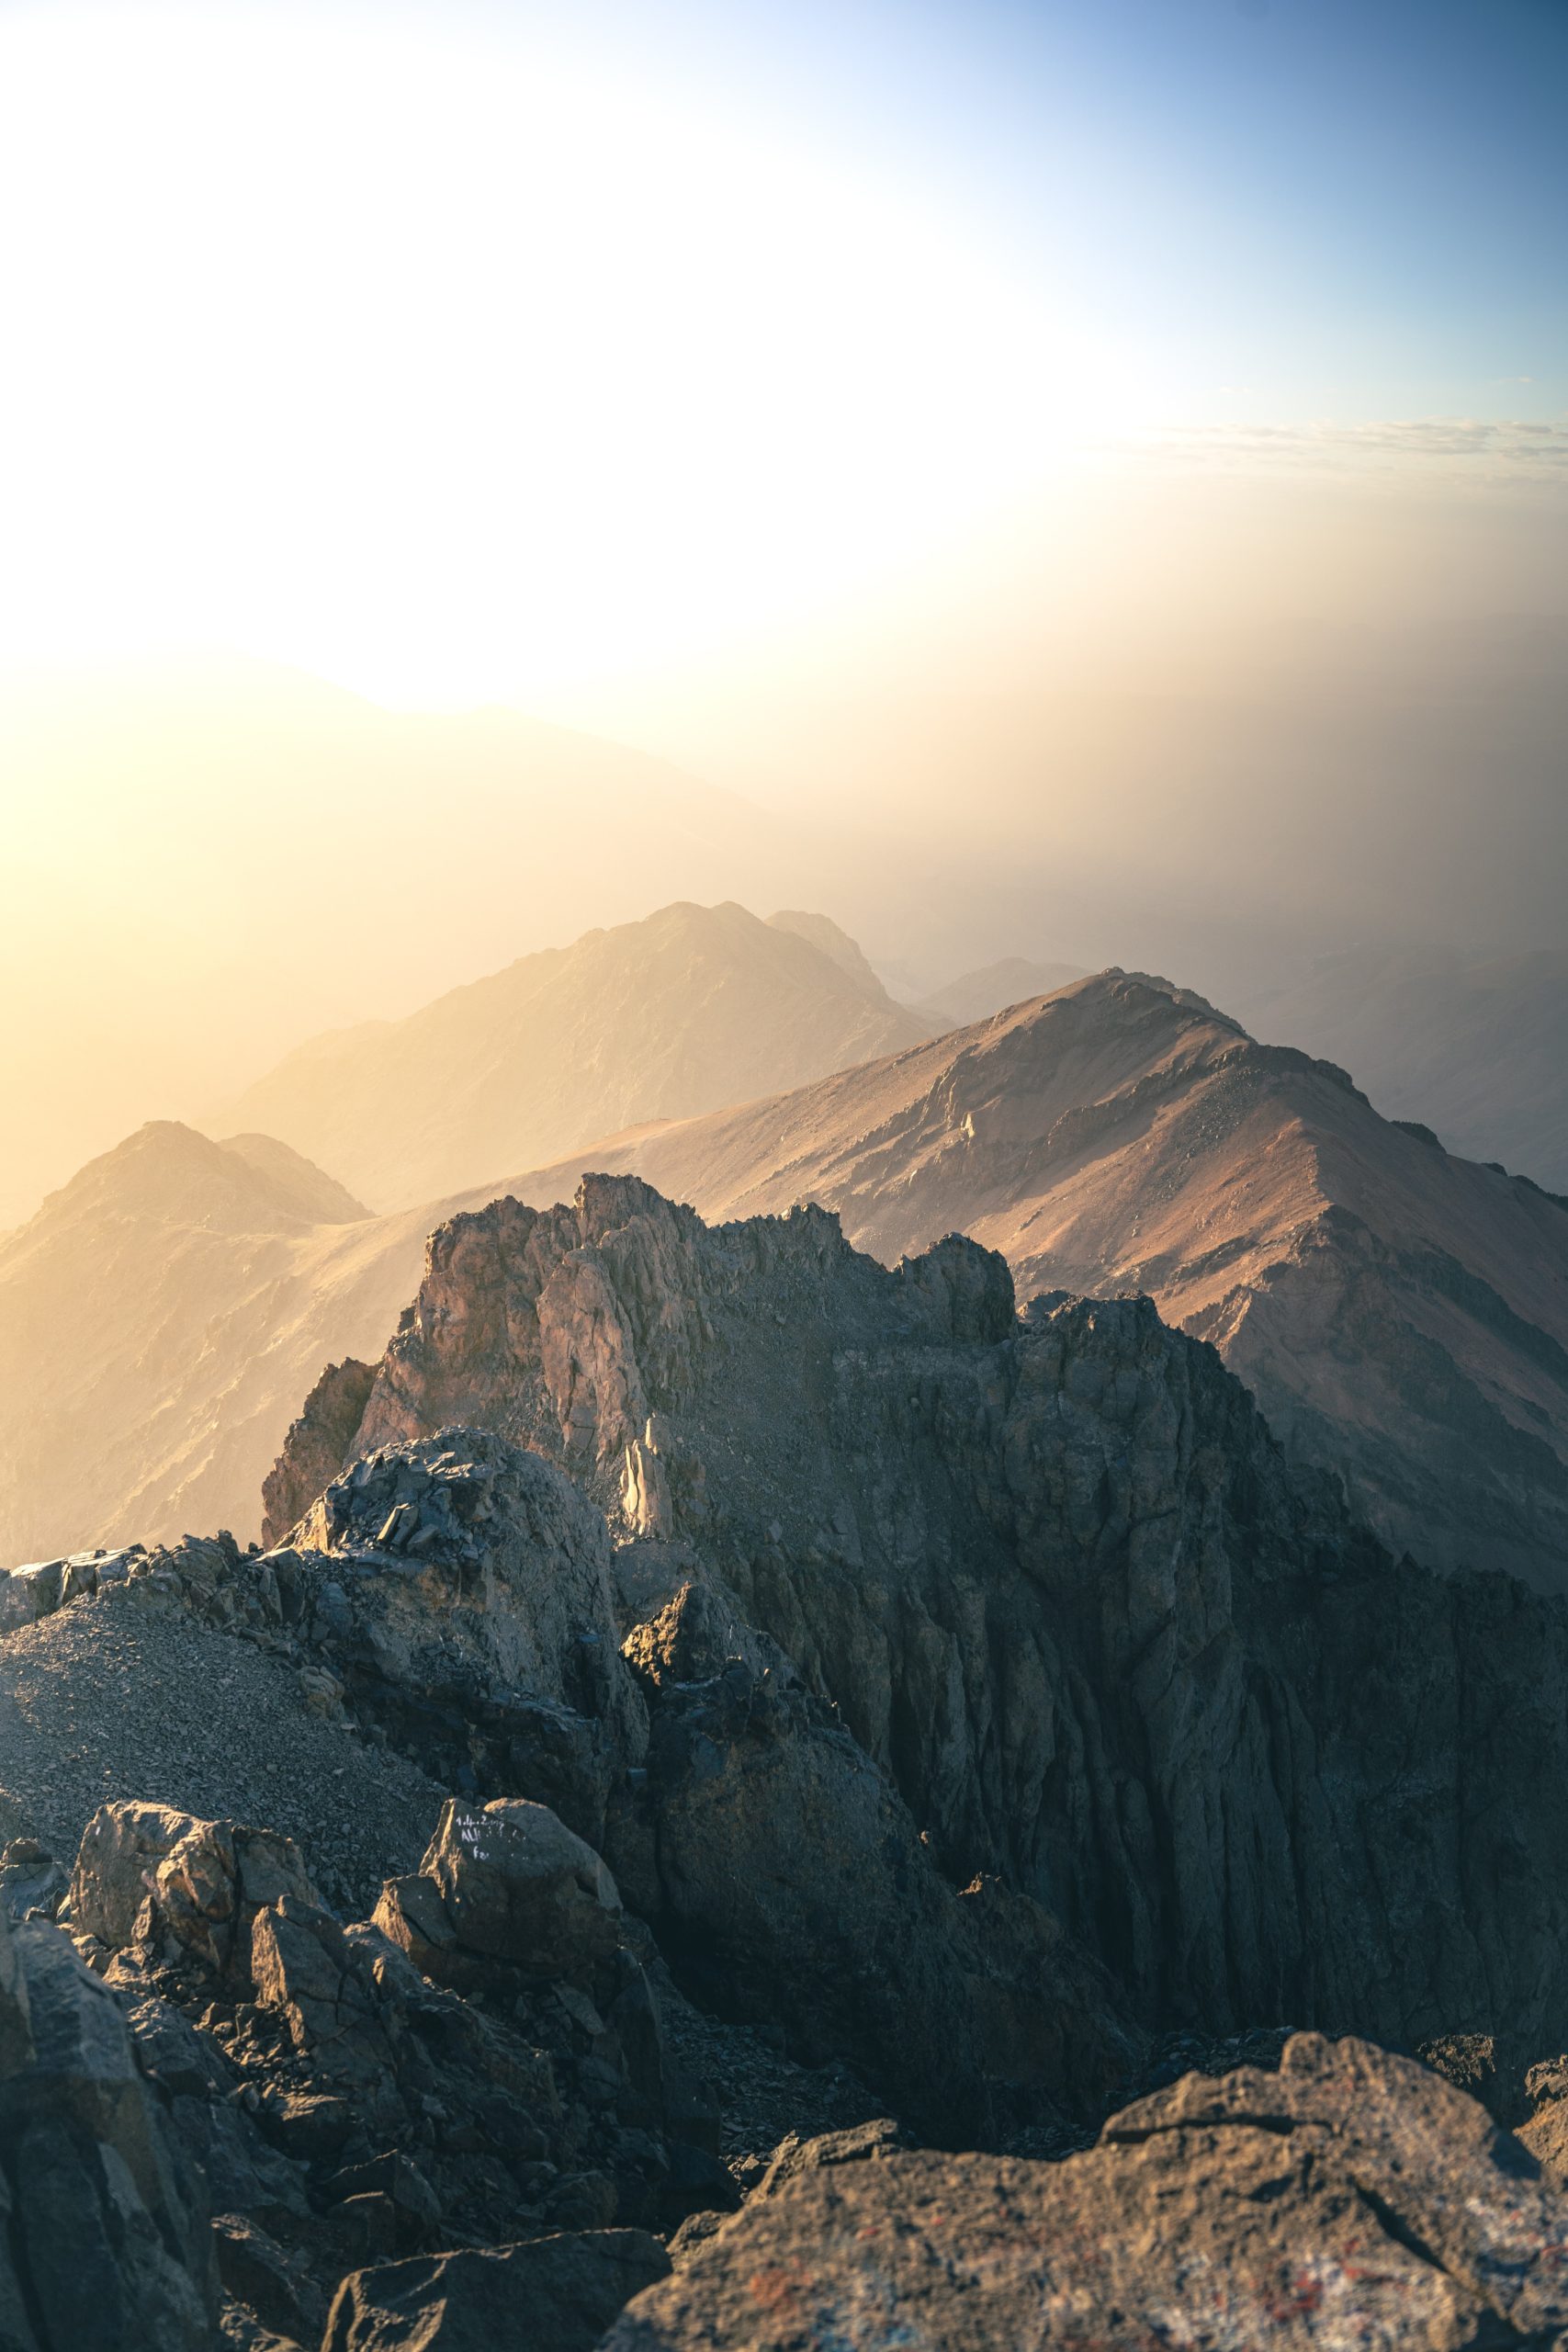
[270,1179,1568,2049]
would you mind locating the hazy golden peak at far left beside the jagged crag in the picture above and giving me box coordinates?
[0,1122,439,1562]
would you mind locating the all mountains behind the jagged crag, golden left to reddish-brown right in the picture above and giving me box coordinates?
[0,906,1568,1588]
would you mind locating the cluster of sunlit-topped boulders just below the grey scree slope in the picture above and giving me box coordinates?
[58,1804,733,2343]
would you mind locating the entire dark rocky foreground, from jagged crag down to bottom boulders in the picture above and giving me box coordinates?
[0,1176,1568,2352]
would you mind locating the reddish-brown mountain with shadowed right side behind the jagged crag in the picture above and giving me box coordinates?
[501,971,1568,1588]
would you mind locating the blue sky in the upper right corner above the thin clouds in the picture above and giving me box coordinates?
[465,0,1568,421]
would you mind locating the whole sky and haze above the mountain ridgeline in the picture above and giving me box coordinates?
[0,0,1568,1221]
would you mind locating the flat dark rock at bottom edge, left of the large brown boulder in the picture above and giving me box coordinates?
[322,2230,670,2352]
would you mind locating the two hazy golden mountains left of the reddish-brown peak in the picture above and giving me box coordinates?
[0,906,931,1566]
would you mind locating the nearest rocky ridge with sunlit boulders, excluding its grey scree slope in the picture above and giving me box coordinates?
[0,1401,1568,2352]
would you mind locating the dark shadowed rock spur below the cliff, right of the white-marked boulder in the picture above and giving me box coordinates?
[614,1636,1138,2145]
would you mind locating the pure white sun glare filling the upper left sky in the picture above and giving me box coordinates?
[0,12,1123,698]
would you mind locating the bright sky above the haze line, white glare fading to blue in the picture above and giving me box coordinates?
[0,0,1568,715]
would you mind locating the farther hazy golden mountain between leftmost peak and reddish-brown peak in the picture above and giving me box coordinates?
[220,903,933,1209]
